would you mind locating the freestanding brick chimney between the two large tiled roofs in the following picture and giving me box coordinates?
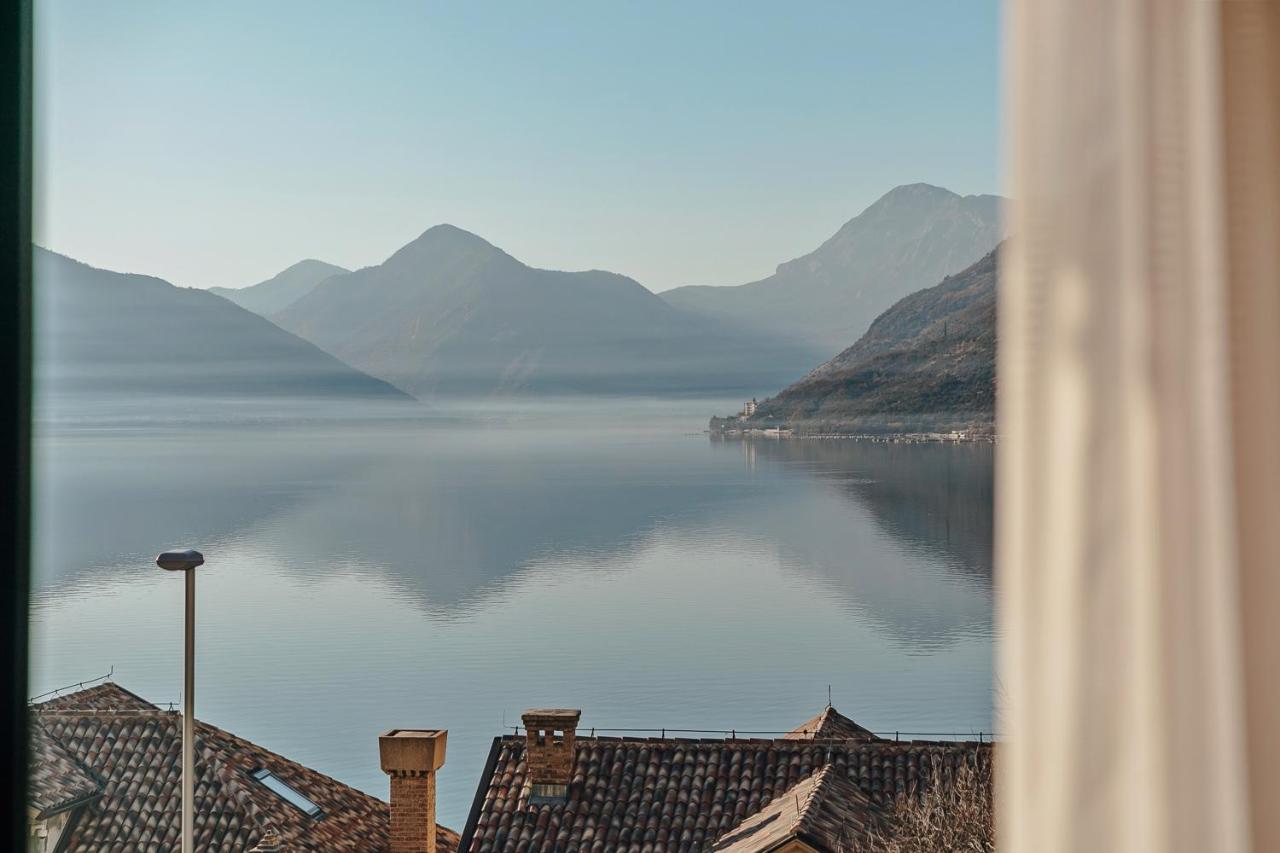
[378,729,449,853]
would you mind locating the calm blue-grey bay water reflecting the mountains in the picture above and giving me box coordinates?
[24,401,993,830]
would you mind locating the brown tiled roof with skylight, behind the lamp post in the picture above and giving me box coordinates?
[31,684,458,853]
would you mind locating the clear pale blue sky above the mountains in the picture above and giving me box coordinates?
[35,0,1000,291]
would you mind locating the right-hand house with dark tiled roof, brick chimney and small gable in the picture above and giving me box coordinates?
[458,706,991,853]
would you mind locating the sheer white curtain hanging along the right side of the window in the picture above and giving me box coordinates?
[996,0,1280,853]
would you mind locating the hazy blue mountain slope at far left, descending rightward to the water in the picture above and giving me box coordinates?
[32,246,404,400]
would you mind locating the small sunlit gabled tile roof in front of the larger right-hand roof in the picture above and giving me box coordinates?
[710,766,882,853]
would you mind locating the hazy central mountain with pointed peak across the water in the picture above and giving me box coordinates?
[271,225,814,397]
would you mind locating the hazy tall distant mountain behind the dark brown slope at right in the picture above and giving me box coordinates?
[662,183,1002,356]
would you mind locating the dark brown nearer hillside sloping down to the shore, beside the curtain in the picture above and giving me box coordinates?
[728,244,998,433]
